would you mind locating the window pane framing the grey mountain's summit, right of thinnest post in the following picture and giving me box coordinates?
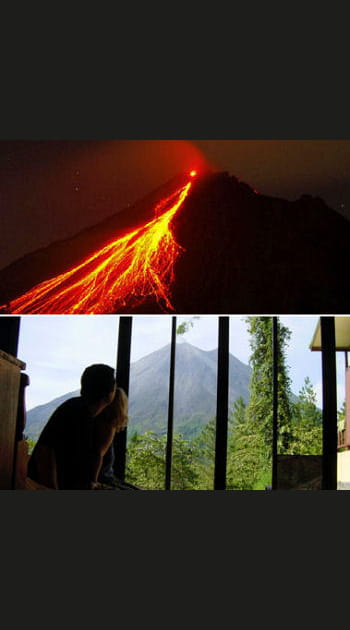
[172,315,218,490]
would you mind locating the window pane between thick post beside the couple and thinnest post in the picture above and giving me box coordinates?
[125,315,171,490]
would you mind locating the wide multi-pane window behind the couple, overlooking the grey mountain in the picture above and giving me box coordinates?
[18,315,345,490]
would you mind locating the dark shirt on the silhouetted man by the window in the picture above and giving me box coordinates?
[28,396,95,490]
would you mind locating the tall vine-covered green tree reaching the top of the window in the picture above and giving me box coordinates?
[228,317,292,490]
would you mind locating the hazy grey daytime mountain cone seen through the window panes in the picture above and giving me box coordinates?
[130,343,251,435]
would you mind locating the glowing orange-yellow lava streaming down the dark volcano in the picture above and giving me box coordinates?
[2,171,196,314]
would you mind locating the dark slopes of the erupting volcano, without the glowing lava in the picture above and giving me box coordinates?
[0,172,350,314]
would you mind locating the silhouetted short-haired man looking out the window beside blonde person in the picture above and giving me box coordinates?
[28,363,116,490]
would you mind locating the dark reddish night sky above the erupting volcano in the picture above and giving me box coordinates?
[0,140,350,268]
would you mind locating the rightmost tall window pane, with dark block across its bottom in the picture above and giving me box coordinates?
[278,315,322,490]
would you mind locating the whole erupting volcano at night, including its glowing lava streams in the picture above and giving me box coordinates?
[0,169,350,315]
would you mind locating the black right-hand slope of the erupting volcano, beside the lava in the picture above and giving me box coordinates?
[173,173,350,315]
